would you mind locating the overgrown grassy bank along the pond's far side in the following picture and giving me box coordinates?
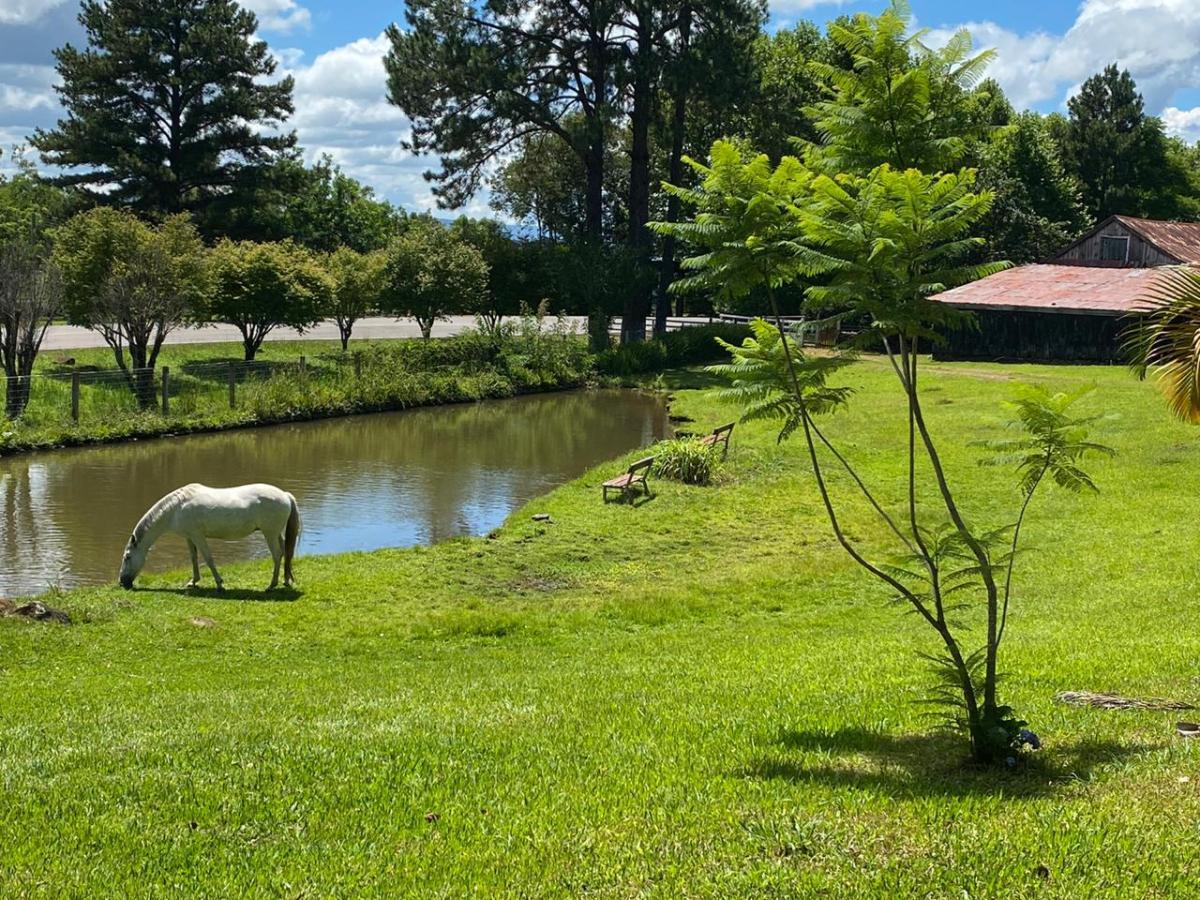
[0,326,593,454]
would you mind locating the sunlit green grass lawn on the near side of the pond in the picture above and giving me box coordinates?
[0,360,1200,898]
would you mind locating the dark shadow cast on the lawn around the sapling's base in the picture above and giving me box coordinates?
[740,727,1156,797]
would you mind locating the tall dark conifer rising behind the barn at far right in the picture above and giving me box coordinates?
[1066,65,1171,220]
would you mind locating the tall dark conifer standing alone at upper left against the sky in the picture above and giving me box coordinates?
[32,0,295,214]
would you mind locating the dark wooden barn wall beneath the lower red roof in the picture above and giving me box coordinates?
[934,310,1129,364]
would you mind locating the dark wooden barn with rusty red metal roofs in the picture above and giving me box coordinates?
[934,216,1200,362]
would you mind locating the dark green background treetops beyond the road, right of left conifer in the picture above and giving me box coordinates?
[203,156,404,253]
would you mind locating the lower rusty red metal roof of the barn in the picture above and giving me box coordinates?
[934,263,1169,316]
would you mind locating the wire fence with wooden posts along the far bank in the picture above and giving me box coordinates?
[2,354,364,428]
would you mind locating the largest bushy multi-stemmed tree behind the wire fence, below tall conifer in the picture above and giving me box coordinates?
[53,206,209,406]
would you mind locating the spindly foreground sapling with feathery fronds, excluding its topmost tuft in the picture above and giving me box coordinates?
[660,144,1100,762]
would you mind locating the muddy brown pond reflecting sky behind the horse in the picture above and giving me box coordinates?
[0,390,670,596]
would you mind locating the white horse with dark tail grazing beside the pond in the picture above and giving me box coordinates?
[120,485,300,590]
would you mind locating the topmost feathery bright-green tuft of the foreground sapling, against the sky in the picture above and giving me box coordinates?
[805,0,995,175]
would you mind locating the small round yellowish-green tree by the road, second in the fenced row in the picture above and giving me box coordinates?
[209,240,334,362]
